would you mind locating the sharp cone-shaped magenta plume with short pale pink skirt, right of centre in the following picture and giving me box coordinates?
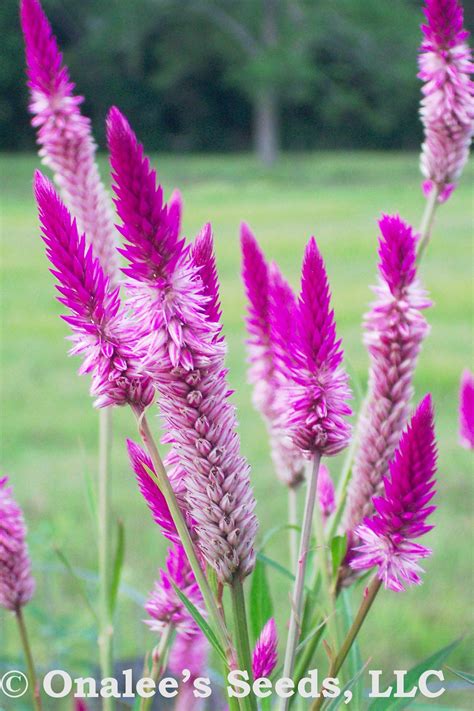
[281,237,351,459]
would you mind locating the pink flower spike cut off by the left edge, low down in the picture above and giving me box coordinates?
[0,477,35,612]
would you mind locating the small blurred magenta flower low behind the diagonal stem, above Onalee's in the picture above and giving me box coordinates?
[145,544,205,638]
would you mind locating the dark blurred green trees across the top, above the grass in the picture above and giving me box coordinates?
[4,0,466,157]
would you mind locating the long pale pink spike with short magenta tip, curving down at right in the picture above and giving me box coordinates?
[345,215,430,552]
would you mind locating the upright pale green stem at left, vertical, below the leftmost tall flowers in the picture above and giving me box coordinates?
[97,408,115,711]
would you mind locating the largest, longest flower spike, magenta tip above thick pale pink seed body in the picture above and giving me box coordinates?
[107,109,257,582]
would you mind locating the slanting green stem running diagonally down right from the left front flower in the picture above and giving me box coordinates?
[133,408,234,666]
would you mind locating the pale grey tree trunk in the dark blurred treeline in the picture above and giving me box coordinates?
[254,89,280,166]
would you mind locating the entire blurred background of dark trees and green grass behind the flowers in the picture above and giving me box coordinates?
[0,0,474,711]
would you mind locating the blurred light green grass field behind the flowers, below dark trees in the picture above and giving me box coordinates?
[0,153,474,708]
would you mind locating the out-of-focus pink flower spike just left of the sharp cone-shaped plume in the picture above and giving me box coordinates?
[241,224,303,486]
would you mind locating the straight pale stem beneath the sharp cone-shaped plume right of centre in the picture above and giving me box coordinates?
[280,453,321,711]
